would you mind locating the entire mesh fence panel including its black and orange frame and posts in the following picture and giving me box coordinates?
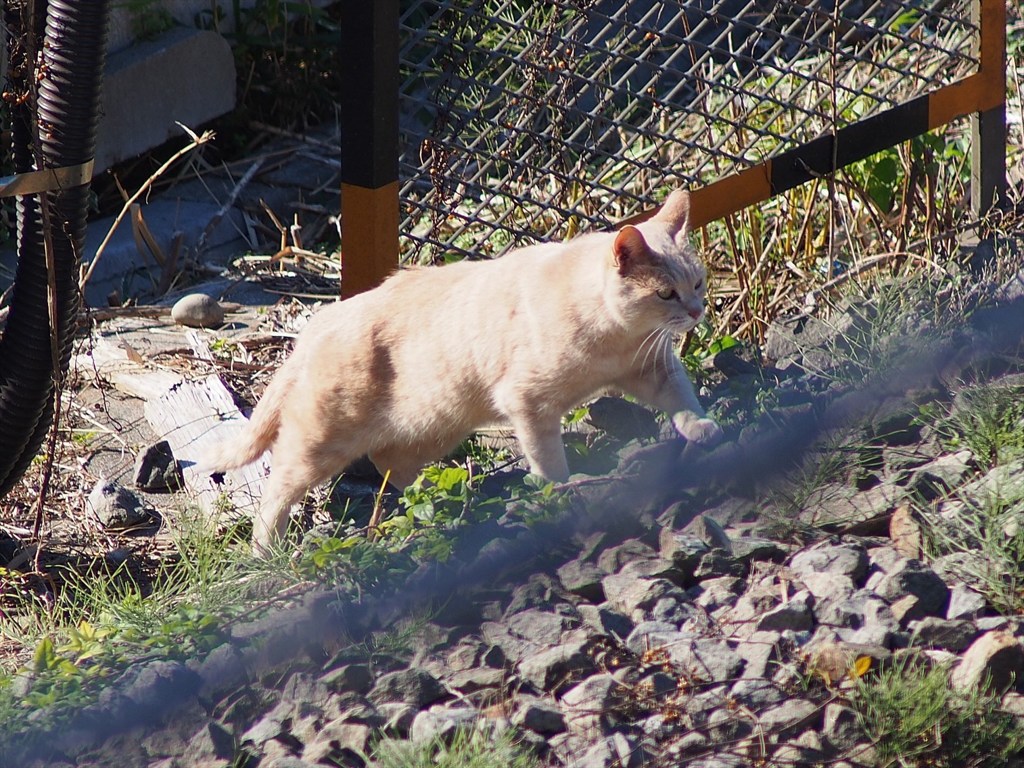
[342,0,1007,295]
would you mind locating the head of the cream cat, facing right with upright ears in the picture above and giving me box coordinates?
[611,189,708,334]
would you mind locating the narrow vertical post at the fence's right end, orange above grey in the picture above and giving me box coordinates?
[971,0,1007,218]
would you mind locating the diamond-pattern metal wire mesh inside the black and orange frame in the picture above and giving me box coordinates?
[399,0,978,261]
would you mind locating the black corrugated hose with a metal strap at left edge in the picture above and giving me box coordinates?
[0,0,108,496]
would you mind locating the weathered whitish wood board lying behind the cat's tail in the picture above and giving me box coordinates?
[144,376,269,519]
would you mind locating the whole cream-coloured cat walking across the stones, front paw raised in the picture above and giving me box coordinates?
[204,190,721,553]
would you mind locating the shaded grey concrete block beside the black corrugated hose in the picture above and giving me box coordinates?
[95,27,234,173]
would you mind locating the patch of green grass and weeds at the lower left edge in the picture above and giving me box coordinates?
[0,514,297,733]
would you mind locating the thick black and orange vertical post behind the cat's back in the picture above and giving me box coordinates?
[340,0,398,298]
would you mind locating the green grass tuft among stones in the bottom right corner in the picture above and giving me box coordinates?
[850,655,1024,768]
